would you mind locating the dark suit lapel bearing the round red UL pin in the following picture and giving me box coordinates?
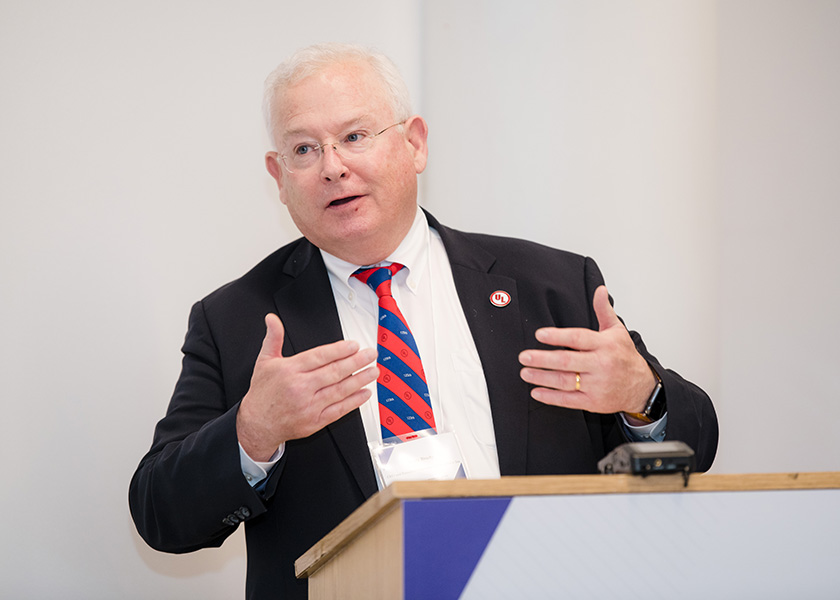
[427,213,529,475]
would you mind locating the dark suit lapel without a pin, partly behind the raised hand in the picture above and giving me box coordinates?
[274,240,377,497]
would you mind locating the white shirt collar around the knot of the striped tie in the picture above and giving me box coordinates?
[320,206,429,304]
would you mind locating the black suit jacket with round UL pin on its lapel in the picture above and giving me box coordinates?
[129,216,718,598]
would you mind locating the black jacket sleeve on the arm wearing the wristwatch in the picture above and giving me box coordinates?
[585,258,718,471]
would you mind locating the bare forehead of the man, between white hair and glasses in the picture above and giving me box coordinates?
[276,62,393,138]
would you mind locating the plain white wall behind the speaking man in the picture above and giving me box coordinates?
[0,0,840,598]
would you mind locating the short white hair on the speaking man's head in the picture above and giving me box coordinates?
[263,42,413,145]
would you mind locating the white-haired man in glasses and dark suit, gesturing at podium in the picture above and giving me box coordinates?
[130,45,717,598]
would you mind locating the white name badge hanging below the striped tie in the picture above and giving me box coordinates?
[370,432,466,489]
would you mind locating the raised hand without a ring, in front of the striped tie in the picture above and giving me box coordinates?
[236,314,378,462]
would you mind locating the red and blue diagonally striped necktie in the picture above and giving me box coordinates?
[353,263,435,442]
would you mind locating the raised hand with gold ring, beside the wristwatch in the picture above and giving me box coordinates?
[519,285,656,413]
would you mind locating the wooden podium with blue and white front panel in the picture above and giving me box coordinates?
[295,473,840,600]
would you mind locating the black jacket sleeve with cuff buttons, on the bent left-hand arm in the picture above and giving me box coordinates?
[129,302,280,552]
